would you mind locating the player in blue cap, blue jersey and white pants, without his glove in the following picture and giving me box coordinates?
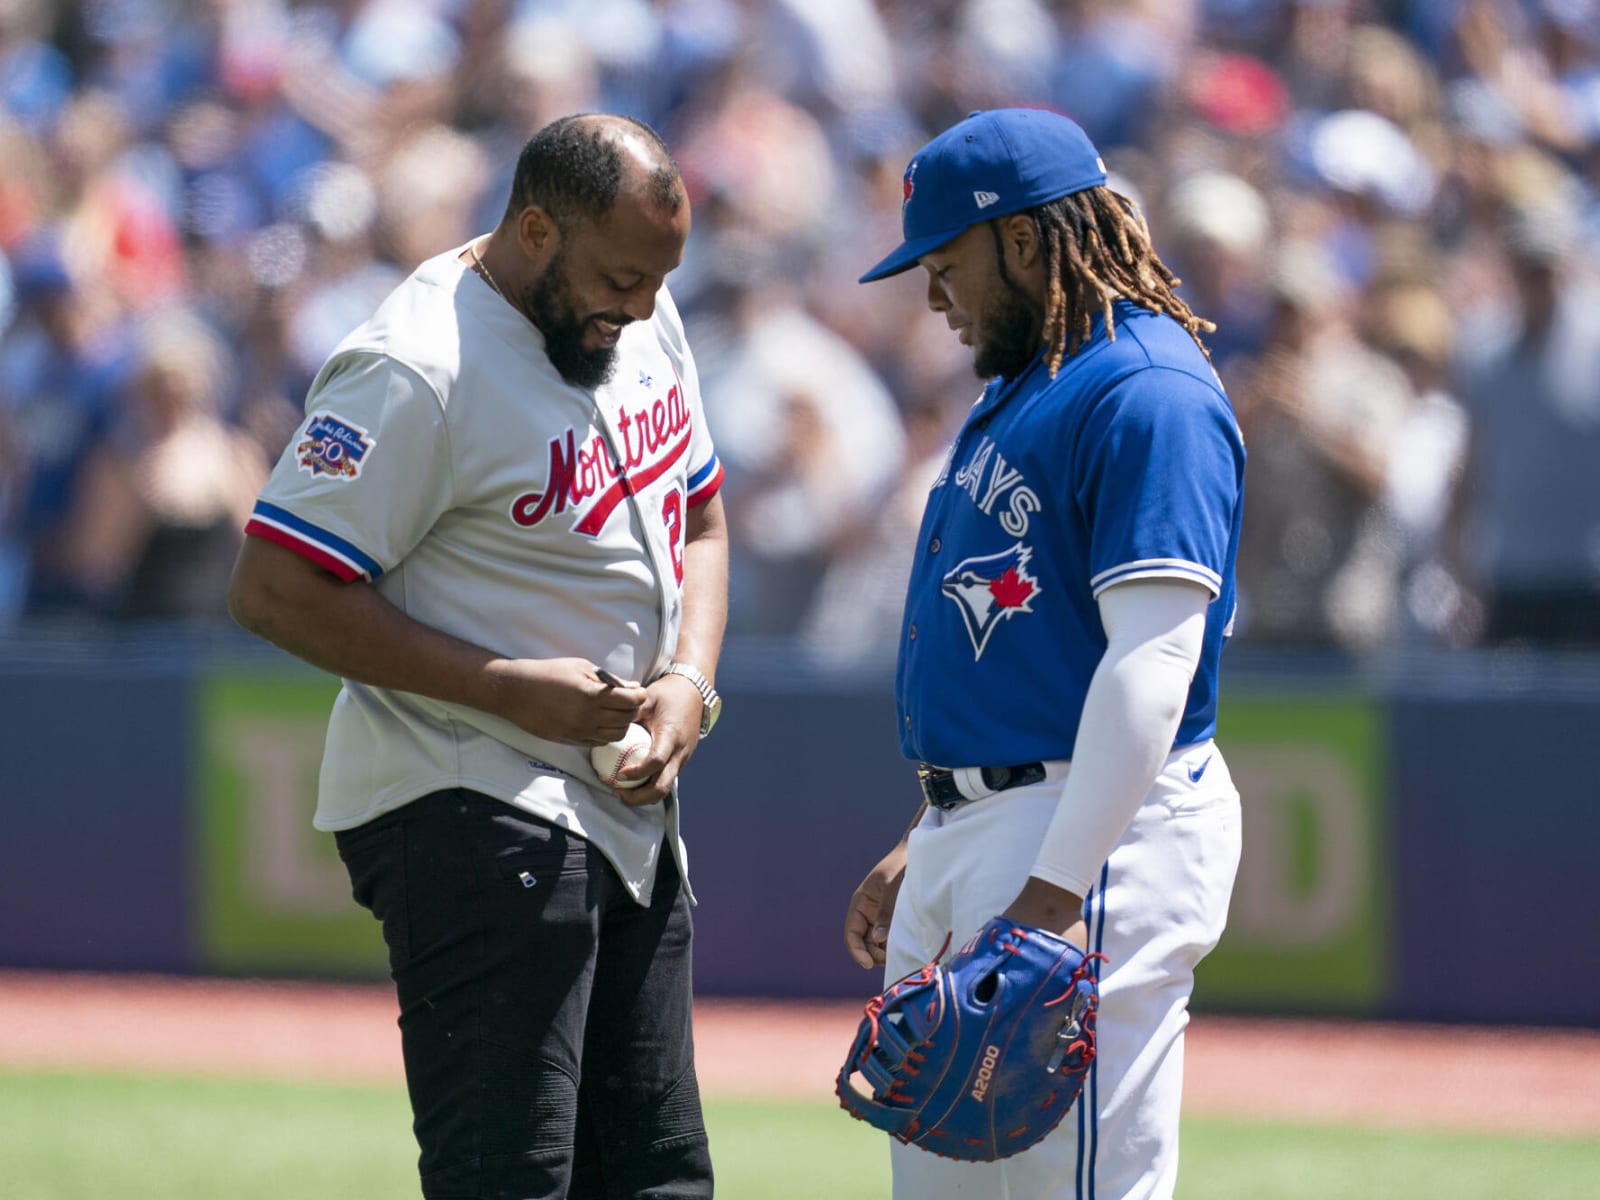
[845,109,1245,1200]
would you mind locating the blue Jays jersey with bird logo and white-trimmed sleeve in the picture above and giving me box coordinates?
[896,301,1245,766]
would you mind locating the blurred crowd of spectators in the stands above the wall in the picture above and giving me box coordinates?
[0,0,1600,662]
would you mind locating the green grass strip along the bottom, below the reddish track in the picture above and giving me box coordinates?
[0,1072,1600,1200]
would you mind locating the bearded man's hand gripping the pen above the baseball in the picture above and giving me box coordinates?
[490,658,645,746]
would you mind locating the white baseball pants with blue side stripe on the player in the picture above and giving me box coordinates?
[885,742,1240,1200]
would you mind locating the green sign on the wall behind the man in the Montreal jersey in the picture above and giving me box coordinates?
[195,667,387,978]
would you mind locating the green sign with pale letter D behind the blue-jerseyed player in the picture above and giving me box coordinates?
[1195,688,1392,1014]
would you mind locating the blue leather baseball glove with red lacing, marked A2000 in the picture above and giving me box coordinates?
[835,917,1101,1162]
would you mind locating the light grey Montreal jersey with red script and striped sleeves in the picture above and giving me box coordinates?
[248,251,723,891]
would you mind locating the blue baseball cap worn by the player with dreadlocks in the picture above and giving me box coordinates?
[861,109,1106,283]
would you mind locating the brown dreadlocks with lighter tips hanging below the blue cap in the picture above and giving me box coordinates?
[1032,187,1216,379]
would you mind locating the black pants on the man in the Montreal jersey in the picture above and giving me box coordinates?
[338,790,712,1200]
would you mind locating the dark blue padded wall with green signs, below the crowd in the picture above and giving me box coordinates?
[0,632,1600,1026]
